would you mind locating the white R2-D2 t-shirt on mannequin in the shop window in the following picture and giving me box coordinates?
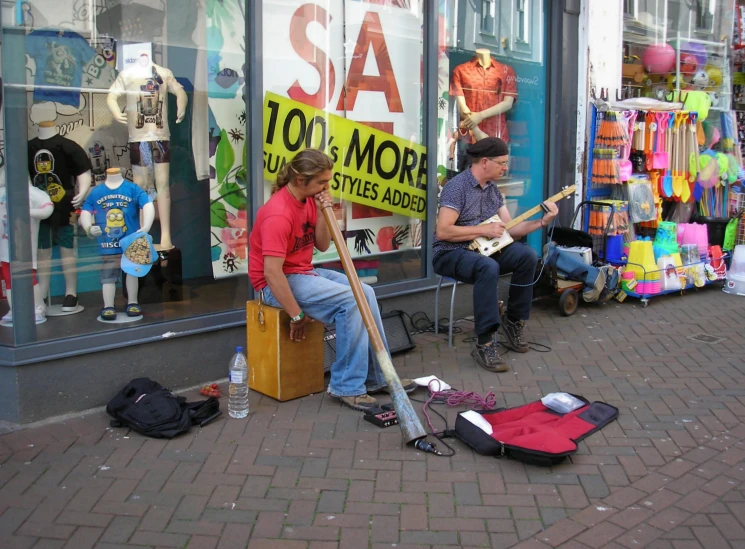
[109,63,184,143]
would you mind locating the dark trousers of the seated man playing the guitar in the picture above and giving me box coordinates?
[433,242,538,335]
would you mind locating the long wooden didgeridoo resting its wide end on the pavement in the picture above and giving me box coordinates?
[323,201,430,446]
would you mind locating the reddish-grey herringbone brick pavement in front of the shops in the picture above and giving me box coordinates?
[0,288,745,549]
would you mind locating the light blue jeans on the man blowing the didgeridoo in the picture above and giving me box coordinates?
[262,269,390,396]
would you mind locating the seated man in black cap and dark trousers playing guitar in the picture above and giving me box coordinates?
[433,137,559,372]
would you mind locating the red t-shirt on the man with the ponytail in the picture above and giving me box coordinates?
[248,187,318,291]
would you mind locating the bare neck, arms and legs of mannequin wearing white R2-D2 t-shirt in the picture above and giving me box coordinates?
[106,52,189,250]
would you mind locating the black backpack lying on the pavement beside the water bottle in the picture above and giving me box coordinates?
[106,377,222,438]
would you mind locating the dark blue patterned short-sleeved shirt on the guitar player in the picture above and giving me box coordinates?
[432,168,504,260]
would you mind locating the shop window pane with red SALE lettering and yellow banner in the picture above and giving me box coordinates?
[263,0,428,284]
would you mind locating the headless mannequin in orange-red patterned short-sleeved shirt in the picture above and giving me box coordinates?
[450,48,517,142]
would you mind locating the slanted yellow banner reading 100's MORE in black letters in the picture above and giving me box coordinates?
[264,93,427,219]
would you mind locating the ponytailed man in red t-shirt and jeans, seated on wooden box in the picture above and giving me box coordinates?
[248,149,416,410]
